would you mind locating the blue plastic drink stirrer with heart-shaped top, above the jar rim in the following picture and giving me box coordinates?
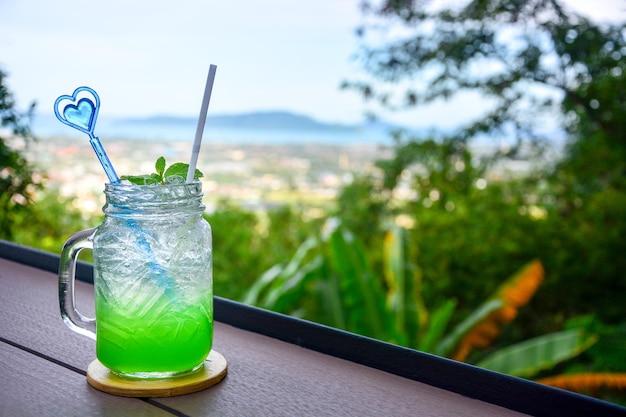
[54,87,120,184]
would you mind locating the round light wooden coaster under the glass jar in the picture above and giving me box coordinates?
[87,350,228,397]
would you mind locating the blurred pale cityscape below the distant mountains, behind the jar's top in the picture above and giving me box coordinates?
[27,136,389,218]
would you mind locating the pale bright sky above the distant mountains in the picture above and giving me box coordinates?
[0,0,626,127]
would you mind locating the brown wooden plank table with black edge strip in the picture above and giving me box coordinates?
[0,241,626,417]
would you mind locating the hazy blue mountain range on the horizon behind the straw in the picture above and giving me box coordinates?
[117,111,392,132]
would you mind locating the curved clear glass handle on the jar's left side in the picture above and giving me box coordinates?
[59,229,96,340]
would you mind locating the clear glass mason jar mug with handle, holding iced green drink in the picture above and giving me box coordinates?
[59,182,213,378]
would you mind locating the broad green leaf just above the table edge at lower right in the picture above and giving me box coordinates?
[476,329,598,378]
